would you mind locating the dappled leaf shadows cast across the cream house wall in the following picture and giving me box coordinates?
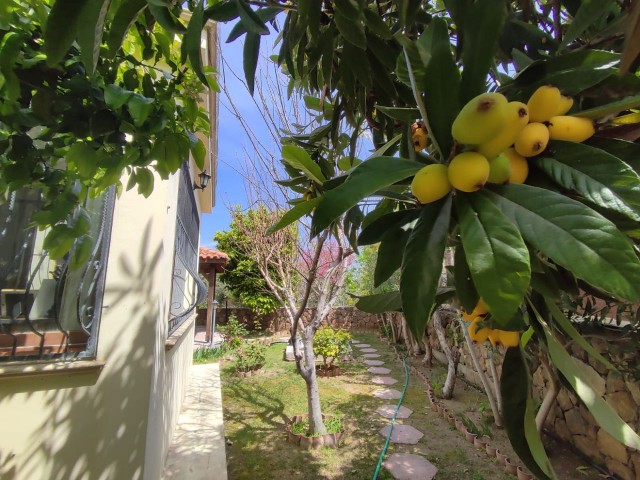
[0,224,161,480]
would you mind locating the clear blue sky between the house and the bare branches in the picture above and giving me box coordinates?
[200,23,273,248]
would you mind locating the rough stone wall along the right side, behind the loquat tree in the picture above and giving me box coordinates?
[420,321,640,480]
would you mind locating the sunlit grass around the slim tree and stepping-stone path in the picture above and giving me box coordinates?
[222,334,510,480]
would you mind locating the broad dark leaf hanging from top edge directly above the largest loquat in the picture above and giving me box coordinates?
[460,0,506,105]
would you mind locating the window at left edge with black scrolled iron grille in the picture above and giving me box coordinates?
[0,189,114,362]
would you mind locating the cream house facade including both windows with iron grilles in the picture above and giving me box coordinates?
[0,25,217,480]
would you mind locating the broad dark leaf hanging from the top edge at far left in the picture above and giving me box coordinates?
[44,0,89,65]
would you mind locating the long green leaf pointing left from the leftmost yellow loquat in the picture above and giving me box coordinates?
[312,157,424,234]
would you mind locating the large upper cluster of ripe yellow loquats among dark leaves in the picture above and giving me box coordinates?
[411,85,595,204]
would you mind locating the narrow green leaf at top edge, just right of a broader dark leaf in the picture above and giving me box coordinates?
[77,0,111,74]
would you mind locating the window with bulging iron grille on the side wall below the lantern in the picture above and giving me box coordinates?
[169,162,207,333]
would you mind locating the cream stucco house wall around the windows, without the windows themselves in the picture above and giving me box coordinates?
[0,172,200,480]
